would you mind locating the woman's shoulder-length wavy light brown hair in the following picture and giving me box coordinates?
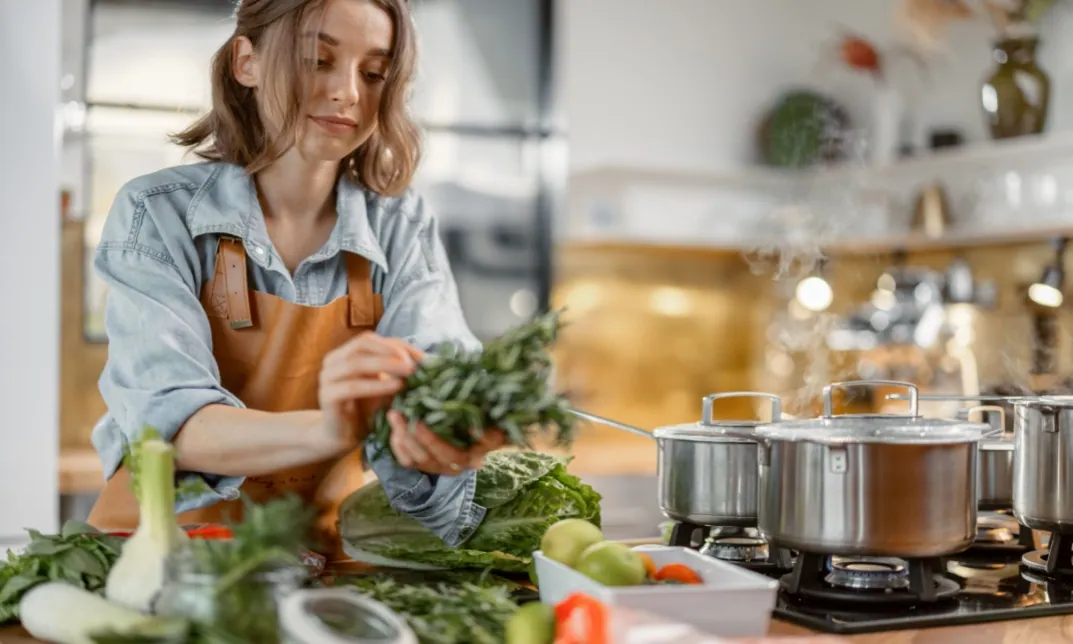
[172,0,421,196]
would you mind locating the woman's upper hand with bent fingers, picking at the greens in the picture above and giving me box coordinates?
[320,332,425,453]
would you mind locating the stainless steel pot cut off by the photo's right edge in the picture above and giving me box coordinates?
[1013,396,1073,533]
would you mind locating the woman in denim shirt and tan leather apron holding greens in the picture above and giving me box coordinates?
[90,0,502,545]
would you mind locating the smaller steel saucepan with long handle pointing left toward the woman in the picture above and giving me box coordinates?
[572,392,782,526]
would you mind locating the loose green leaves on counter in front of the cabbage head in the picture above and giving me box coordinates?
[339,575,518,644]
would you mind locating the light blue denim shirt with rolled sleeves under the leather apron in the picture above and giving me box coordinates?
[92,163,485,545]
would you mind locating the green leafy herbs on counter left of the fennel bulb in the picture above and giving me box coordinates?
[0,521,122,624]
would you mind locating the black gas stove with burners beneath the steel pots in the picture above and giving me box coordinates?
[677,512,1073,634]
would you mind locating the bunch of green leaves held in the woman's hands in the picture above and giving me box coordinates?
[370,311,574,451]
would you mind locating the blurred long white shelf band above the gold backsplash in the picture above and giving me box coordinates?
[561,132,1073,253]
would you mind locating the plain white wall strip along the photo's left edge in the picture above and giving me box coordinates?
[0,0,60,544]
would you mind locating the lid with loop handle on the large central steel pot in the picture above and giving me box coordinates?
[755,380,993,444]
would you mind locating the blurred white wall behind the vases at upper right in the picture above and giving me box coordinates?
[559,0,1073,172]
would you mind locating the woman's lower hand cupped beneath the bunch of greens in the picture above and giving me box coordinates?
[387,410,506,475]
